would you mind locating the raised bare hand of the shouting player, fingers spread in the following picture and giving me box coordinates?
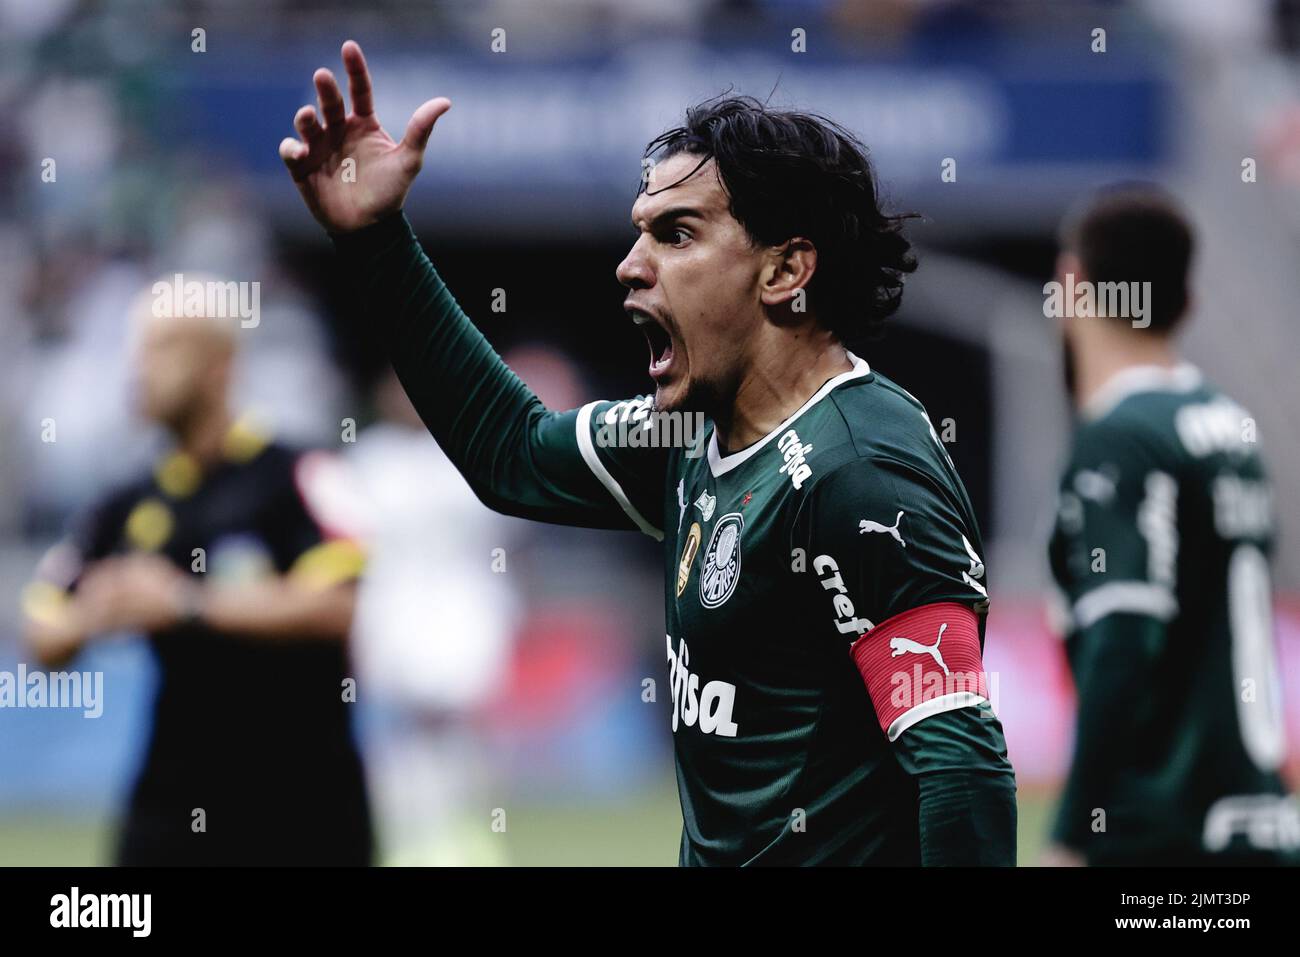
[280,40,451,233]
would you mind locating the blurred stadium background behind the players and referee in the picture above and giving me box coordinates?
[0,0,1300,865]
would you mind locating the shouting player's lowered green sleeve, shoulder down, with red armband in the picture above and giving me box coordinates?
[793,459,1015,866]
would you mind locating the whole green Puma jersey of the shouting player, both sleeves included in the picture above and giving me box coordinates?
[335,210,1015,865]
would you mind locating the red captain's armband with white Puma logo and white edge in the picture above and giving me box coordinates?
[849,602,988,741]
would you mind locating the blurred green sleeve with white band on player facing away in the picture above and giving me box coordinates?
[1053,419,1179,859]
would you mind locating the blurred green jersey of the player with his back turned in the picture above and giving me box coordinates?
[1050,365,1300,863]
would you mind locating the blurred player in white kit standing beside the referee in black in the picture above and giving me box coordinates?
[327,373,519,866]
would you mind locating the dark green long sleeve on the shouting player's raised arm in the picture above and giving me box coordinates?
[333,213,664,533]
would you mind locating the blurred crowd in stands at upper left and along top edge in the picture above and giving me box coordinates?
[0,0,1300,522]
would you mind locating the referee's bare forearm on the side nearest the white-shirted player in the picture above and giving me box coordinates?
[192,577,356,641]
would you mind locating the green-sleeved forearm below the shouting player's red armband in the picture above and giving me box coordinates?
[894,705,1015,867]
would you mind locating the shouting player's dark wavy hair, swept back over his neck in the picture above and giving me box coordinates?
[642,94,917,347]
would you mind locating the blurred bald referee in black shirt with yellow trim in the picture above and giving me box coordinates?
[23,282,372,865]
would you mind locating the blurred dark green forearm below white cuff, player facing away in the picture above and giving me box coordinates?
[1052,614,1165,850]
